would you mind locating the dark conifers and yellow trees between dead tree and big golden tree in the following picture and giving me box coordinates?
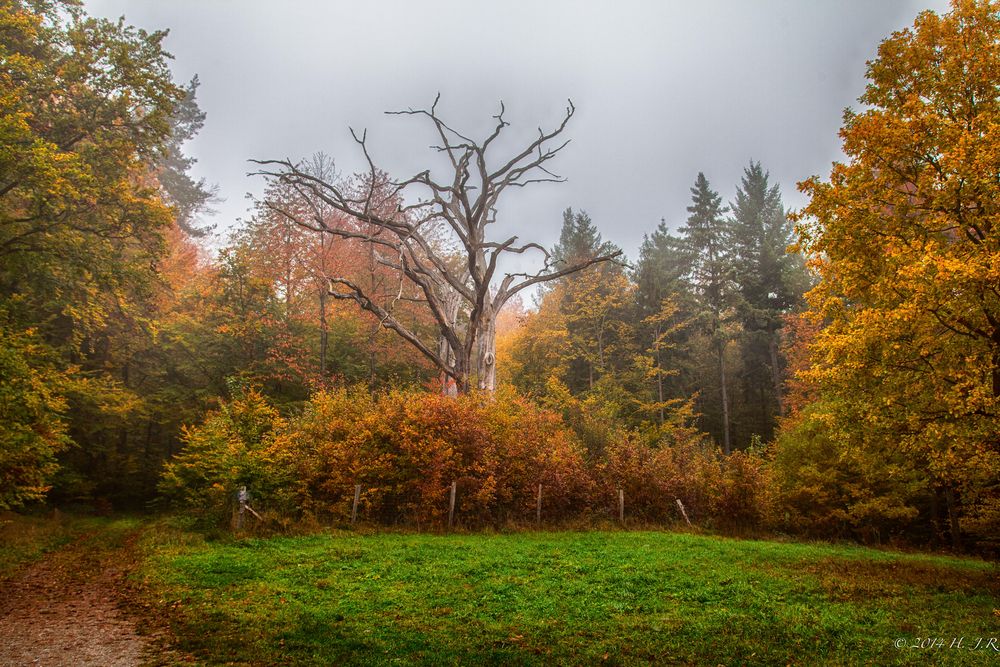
[508,167,809,454]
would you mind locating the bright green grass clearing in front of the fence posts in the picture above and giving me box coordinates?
[135,525,1000,665]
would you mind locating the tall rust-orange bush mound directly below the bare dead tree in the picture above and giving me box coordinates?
[276,389,590,526]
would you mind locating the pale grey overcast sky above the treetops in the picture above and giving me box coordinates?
[86,0,946,258]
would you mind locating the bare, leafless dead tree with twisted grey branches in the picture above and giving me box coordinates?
[253,96,620,393]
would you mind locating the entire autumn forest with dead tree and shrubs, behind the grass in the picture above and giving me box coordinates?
[0,0,1000,553]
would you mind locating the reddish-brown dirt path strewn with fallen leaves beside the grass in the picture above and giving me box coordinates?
[0,530,166,667]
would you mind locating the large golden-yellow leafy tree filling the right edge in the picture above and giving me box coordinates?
[797,0,1000,541]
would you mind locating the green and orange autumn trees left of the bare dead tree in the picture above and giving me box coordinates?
[0,0,433,509]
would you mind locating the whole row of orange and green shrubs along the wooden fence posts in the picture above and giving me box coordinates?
[160,389,780,528]
